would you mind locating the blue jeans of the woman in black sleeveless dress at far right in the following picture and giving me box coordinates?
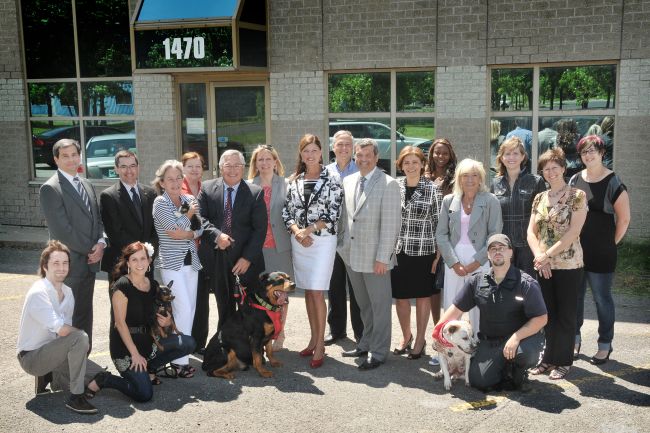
[576,272,615,350]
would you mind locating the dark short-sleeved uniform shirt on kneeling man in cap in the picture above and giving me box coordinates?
[454,266,547,338]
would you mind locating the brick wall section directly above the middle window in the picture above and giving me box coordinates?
[322,0,438,69]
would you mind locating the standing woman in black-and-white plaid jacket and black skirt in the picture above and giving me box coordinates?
[391,146,442,359]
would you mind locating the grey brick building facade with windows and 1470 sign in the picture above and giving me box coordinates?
[0,0,650,238]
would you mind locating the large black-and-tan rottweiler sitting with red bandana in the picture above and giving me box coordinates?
[203,272,296,379]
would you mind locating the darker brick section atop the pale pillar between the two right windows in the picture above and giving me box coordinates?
[432,0,487,66]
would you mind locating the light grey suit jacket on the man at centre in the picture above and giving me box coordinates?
[338,168,402,273]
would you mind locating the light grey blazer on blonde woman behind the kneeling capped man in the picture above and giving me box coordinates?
[436,192,503,267]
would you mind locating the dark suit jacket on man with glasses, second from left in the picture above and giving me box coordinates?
[99,181,158,273]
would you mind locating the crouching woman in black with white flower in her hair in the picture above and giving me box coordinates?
[86,242,196,402]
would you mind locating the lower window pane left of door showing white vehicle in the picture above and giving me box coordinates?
[84,120,137,179]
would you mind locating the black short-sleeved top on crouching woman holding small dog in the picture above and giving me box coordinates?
[109,276,158,372]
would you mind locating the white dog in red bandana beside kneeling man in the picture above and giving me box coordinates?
[433,320,478,391]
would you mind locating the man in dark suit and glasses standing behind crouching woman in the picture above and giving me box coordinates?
[99,150,158,286]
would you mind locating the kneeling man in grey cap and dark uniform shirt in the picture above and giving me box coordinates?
[433,234,548,390]
